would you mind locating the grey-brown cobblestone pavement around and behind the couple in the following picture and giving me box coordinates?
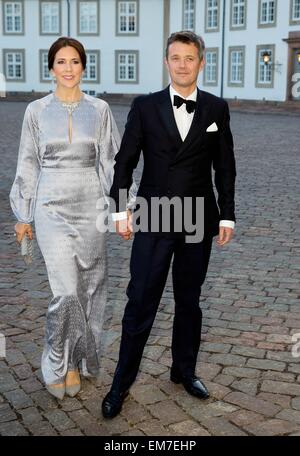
[0,101,300,436]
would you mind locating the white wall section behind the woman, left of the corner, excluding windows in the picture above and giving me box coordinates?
[0,0,163,93]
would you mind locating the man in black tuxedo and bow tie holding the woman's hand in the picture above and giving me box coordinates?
[102,31,236,418]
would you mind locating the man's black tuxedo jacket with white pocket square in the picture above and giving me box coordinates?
[110,87,236,236]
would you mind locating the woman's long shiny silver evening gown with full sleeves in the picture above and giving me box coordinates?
[10,94,120,384]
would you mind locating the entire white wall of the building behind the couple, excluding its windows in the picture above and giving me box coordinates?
[0,0,300,101]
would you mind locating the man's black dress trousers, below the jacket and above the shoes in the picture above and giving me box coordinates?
[112,232,212,391]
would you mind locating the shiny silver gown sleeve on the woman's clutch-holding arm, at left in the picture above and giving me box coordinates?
[9,106,40,223]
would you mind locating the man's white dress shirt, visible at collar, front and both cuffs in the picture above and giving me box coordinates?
[112,85,235,229]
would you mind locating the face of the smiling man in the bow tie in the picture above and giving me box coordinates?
[165,41,205,88]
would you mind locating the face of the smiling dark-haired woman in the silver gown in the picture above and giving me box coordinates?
[51,46,84,89]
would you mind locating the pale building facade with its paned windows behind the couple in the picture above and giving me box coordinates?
[0,0,300,101]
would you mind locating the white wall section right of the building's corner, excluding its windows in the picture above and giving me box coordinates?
[170,0,300,101]
